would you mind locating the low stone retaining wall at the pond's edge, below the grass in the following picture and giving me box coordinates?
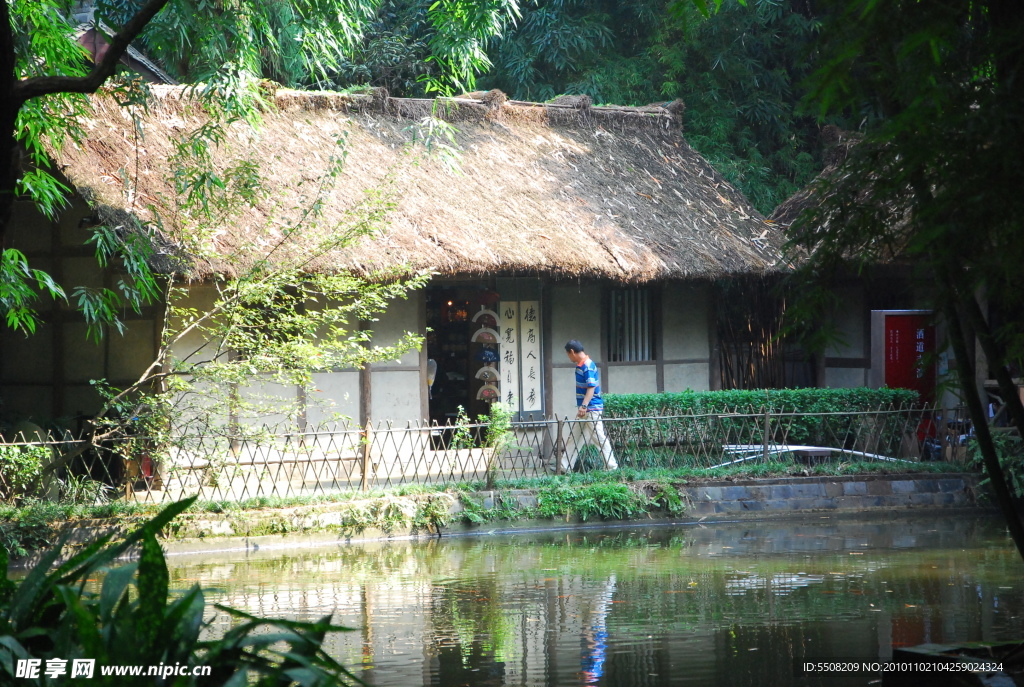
[157,473,980,553]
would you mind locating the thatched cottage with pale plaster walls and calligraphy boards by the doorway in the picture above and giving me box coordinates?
[0,87,787,430]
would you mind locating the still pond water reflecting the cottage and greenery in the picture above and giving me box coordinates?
[168,514,1024,687]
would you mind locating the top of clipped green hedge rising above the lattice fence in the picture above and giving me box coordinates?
[604,387,920,418]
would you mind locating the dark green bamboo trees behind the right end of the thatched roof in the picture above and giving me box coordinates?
[481,0,820,214]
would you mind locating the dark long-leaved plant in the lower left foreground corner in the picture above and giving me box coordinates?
[0,501,362,687]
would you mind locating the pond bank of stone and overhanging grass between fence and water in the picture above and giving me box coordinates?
[6,473,981,565]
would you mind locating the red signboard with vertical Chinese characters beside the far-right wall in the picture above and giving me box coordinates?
[885,312,935,402]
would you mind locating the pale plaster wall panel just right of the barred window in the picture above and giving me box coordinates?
[662,282,711,362]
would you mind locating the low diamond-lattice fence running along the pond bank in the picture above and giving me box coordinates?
[0,406,969,503]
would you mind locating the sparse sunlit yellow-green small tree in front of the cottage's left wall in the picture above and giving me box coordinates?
[40,111,429,480]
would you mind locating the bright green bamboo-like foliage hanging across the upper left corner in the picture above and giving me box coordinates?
[0,0,518,333]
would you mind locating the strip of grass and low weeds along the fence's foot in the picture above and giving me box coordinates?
[0,461,966,556]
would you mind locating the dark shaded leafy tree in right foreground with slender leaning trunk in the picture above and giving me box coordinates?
[794,0,1024,555]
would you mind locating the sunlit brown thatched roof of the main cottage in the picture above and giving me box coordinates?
[56,87,785,282]
